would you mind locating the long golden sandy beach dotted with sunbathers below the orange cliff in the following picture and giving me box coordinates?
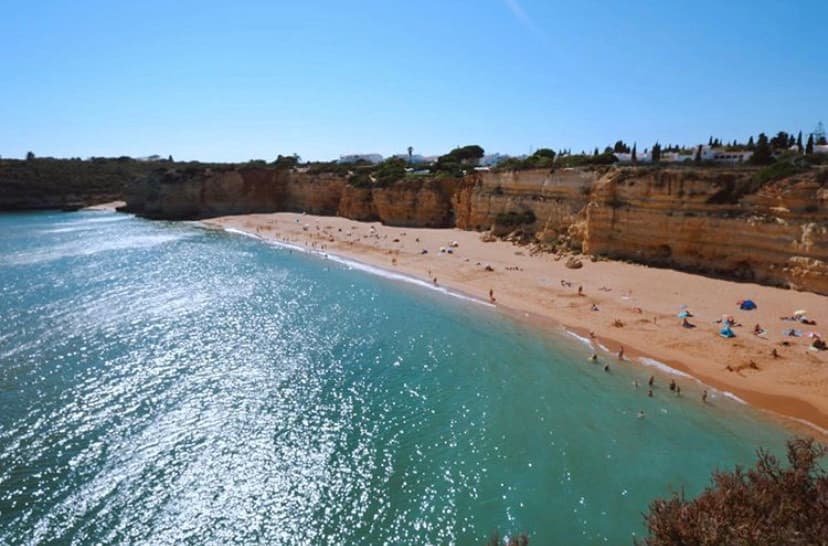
[205,213,828,440]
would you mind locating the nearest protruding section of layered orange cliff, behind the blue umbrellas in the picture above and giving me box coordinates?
[583,169,828,293]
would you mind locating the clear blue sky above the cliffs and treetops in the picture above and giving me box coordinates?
[0,0,828,161]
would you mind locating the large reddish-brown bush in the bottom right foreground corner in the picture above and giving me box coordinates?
[644,439,828,546]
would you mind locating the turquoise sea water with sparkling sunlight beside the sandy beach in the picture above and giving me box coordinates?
[0,212,787,545]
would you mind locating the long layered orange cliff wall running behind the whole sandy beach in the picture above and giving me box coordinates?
[127,167,828,294]
